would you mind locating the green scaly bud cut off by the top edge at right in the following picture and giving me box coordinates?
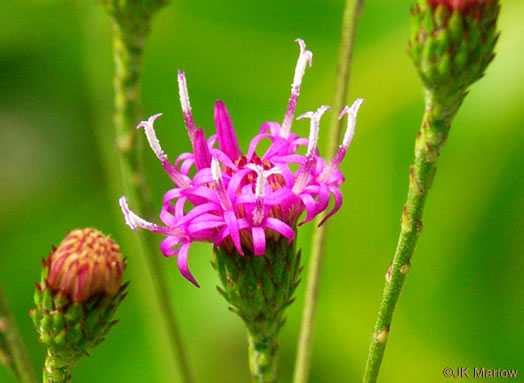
[409,0,500,113]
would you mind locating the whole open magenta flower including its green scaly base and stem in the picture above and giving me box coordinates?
[120,40,362,382]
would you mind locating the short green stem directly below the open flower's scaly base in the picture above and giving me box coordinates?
[248,333,278,383]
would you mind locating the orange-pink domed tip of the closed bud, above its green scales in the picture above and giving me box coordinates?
[47,229,125,302]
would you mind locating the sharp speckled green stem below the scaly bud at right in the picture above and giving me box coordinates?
[364,91,454,383]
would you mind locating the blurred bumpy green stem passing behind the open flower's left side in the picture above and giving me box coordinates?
[113,22,193,383]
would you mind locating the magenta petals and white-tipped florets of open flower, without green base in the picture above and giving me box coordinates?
[120,40,362,286]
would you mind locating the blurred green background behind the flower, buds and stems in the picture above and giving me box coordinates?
[0,0,524,383]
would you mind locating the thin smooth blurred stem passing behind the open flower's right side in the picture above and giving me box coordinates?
[293,0,364,383]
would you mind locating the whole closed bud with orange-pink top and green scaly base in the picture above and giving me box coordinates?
[30,229,127,383]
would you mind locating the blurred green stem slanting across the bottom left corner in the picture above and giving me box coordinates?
[0,288,37,383]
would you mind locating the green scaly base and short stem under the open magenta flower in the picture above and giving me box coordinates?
[214,238,302,383]
